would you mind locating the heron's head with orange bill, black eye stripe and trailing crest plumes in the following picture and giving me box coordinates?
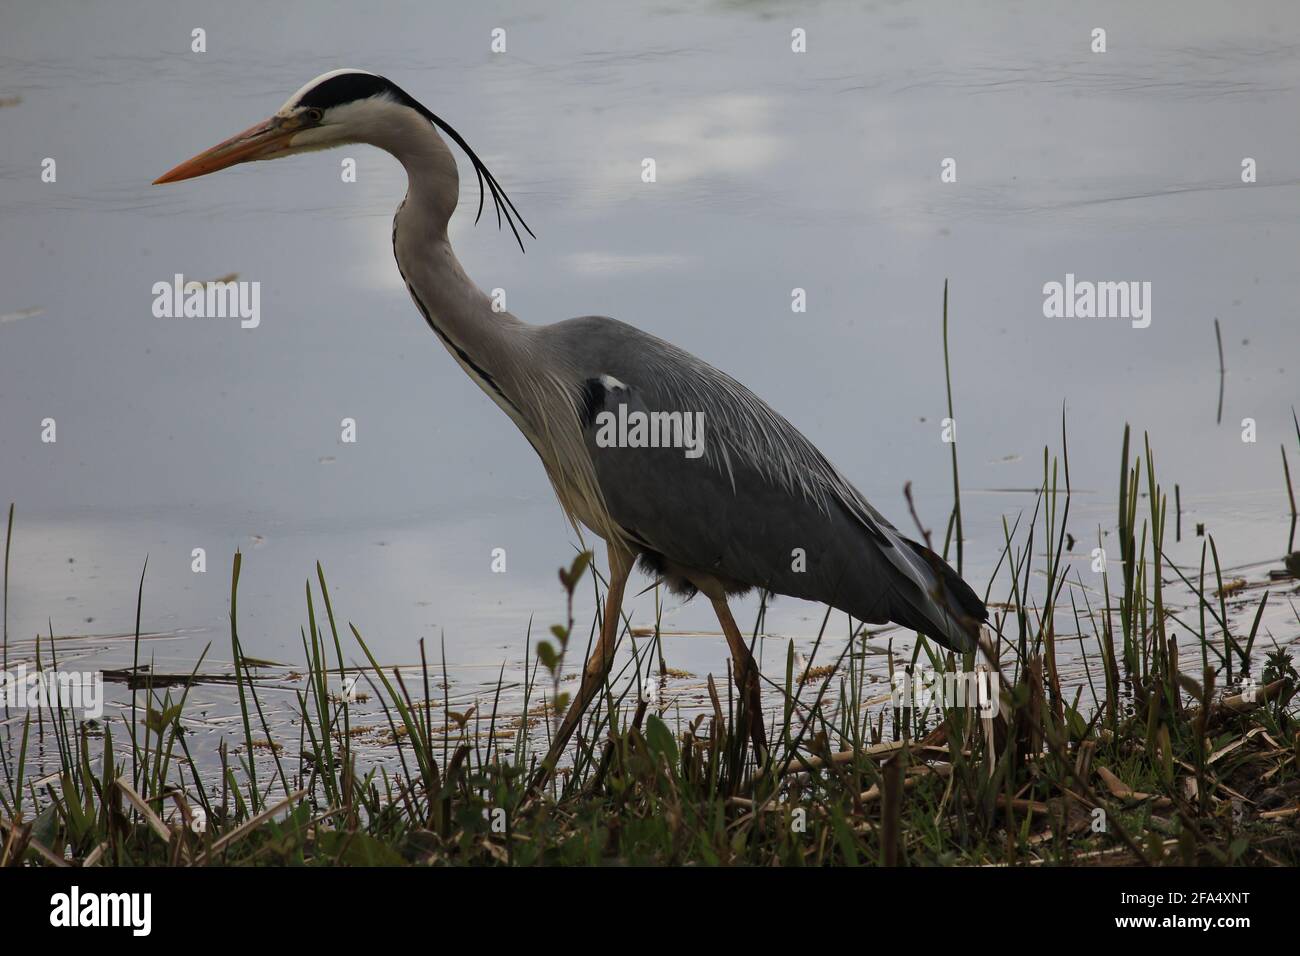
[153,70,532,248]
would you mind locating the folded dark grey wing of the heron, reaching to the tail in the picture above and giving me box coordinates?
[553,319,987,650]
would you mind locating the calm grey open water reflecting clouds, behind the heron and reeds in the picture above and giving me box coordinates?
[0,3,1300,743]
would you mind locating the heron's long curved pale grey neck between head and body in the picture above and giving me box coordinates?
[386,118,529,424]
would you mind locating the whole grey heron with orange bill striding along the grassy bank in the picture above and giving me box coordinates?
[156,70,988,770]
